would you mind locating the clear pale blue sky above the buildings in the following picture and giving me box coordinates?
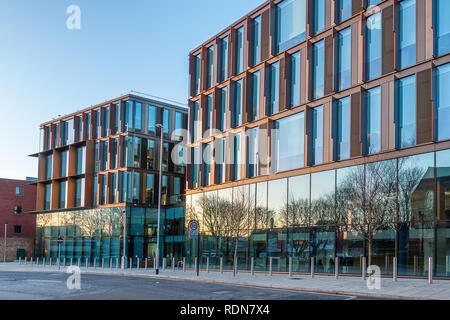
[0,0,265,179]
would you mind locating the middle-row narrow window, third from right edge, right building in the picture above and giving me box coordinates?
[365,12,381,81]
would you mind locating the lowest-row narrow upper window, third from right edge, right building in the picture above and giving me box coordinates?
[365,87,381,154]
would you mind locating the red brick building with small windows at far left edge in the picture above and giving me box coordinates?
[0,179,36,261]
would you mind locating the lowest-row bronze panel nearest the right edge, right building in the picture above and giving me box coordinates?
[416,69,433,144]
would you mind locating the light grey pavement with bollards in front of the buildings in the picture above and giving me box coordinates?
[0,262,450,300]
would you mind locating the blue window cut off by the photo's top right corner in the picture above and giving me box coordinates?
[434,0,450,56]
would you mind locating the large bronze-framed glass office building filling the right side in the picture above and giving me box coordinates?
[186,0,450,277]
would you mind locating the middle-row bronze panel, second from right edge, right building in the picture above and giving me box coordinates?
[381,6,395,74]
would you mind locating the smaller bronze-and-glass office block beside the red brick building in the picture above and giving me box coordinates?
[33,94,188,265]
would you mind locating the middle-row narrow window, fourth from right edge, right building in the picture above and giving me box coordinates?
[336,27,352,91]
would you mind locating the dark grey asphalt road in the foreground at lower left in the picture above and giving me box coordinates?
[0,272,380,300]
